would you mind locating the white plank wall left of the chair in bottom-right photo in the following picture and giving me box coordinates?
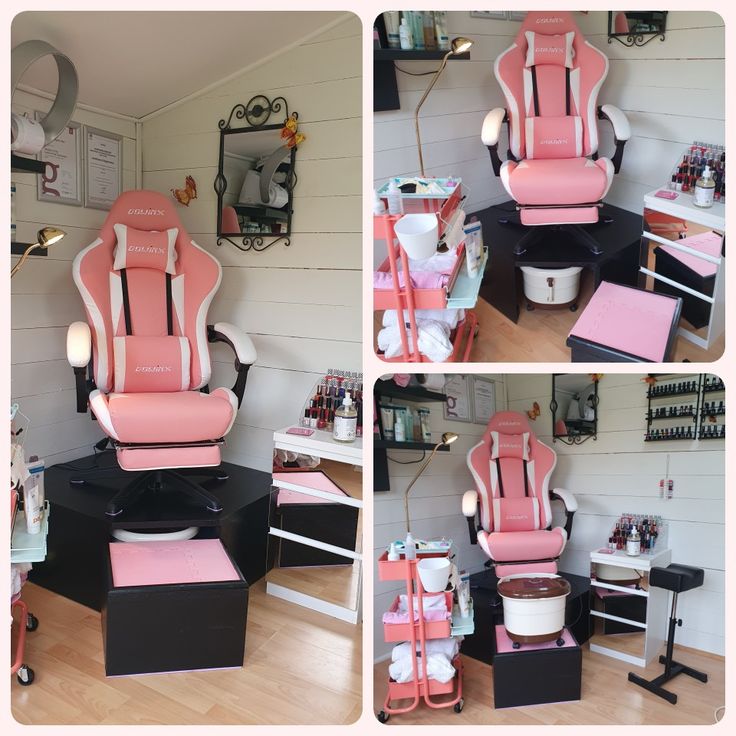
[373,376,506,659]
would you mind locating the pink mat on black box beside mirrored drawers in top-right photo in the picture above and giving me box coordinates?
[570,281,677,362]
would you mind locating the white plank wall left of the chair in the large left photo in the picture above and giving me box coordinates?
[10,91,136,464]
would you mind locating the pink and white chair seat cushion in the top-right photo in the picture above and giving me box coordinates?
[501,158,613,205]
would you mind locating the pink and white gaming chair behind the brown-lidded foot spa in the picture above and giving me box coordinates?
[463,411,577,578]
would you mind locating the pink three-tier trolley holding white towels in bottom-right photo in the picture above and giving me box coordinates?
[377,551,473,723]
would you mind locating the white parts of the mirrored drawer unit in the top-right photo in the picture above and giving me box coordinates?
[639,187,726,350]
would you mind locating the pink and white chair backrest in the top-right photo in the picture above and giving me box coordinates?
[494,11,608,160]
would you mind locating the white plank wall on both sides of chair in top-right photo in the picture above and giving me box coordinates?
[374,11,725,212]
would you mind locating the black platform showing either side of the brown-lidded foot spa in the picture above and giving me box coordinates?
[460,570,591,664]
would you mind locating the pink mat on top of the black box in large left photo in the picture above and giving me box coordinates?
[110,539,241,588]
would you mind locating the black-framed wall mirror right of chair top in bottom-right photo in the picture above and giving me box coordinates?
[549,373,598,445]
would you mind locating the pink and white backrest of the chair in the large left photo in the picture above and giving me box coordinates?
[73,190,222,393]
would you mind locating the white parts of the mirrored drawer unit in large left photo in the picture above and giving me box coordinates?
[266,427,363,624]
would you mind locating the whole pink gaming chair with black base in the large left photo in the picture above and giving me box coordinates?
[67,191,256,516]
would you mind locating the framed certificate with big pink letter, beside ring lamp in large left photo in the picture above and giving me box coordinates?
[36,118,83,207]
